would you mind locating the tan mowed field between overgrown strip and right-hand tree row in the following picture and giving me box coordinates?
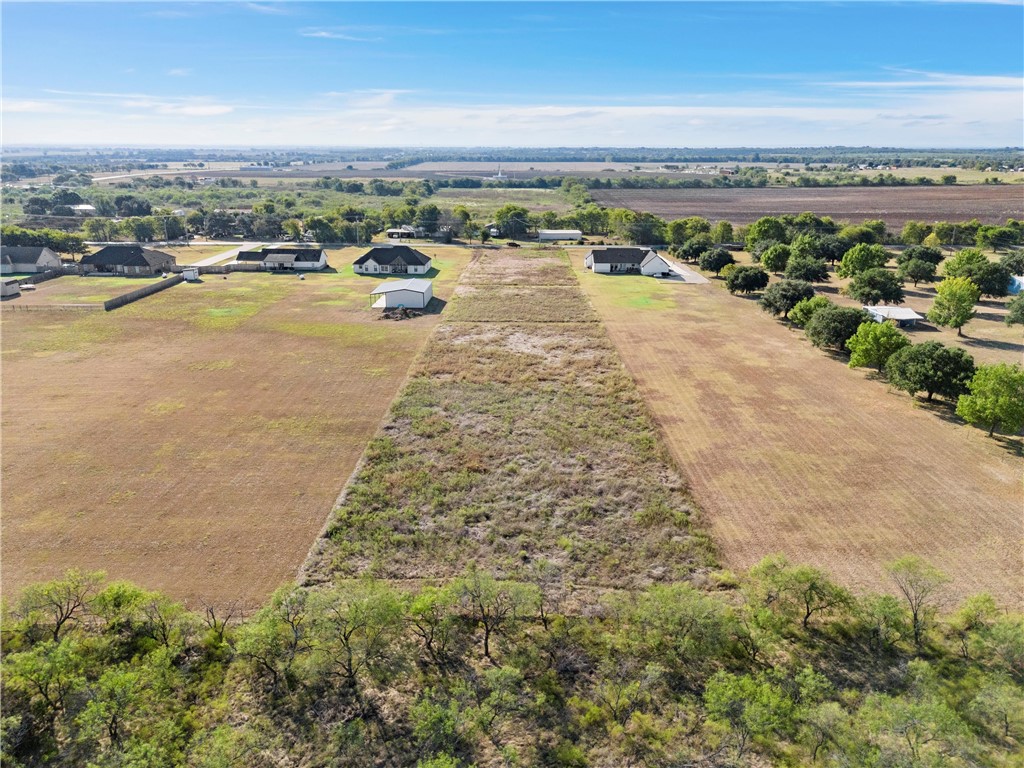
[575,268,1024,607]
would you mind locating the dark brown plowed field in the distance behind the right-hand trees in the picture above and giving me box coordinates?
[592,184,1024,230]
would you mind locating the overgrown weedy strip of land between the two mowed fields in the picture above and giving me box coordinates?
[307,251,714,588]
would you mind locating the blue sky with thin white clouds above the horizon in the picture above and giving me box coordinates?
[0,0,1024,146]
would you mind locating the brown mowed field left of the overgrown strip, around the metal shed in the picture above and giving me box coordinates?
[0,249,469,607]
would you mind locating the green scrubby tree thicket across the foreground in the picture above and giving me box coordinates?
[2,556,1024,768]
